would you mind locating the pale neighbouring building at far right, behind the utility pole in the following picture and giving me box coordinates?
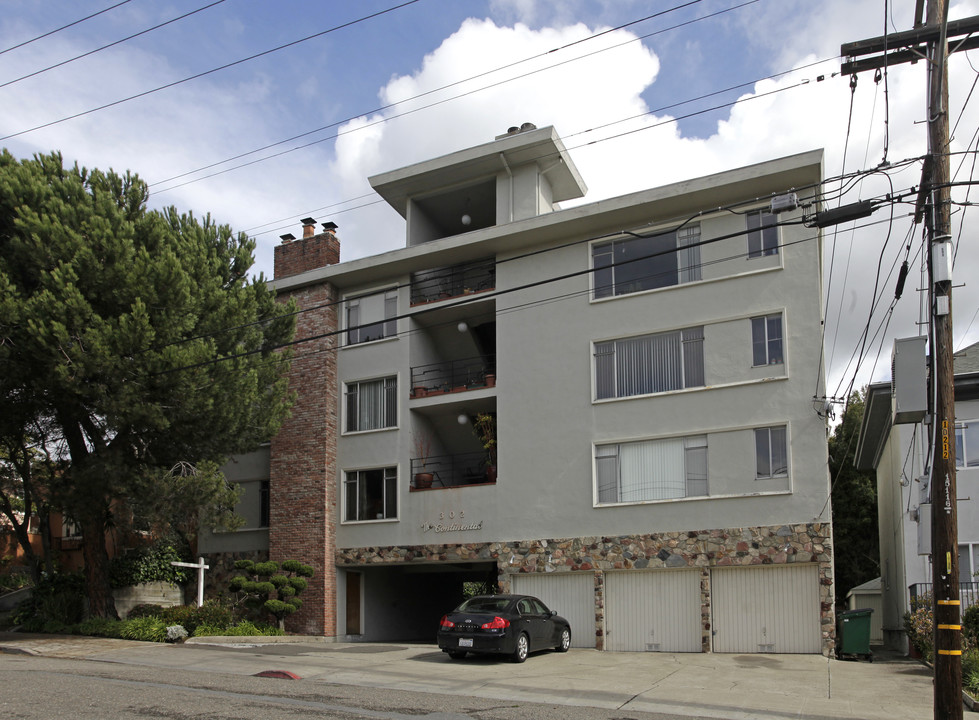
[856,338,979,652]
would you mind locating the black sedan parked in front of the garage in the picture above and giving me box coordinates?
[438,595,571,662]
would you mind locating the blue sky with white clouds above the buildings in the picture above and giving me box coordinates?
[0,0,979,410]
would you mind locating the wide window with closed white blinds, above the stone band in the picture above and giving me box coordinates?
[595,435,707,503]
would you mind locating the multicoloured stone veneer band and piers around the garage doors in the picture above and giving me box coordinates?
[336,523,836,656]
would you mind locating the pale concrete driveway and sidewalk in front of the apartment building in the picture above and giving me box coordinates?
[0,633,933,720]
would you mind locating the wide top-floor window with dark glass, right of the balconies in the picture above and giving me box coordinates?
[591,225,700,299]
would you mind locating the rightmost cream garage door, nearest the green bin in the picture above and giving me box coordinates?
[711,565,821,653]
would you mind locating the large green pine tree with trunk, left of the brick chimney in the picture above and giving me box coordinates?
[0,150,295,615]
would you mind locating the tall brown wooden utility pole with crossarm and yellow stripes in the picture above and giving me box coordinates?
[840,0,979,720]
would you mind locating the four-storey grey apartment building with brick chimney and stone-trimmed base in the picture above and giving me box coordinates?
[214,124,835,653]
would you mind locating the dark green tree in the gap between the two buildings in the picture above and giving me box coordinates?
[829,392,880,607]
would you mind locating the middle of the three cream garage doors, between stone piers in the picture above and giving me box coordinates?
[605,570,702,652]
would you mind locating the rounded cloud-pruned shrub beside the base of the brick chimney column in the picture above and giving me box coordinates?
[228,560,314,628]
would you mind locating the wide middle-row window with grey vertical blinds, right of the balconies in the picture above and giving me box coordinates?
[595,327,704,400]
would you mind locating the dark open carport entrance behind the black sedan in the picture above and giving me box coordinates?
[338,562,498,644]
